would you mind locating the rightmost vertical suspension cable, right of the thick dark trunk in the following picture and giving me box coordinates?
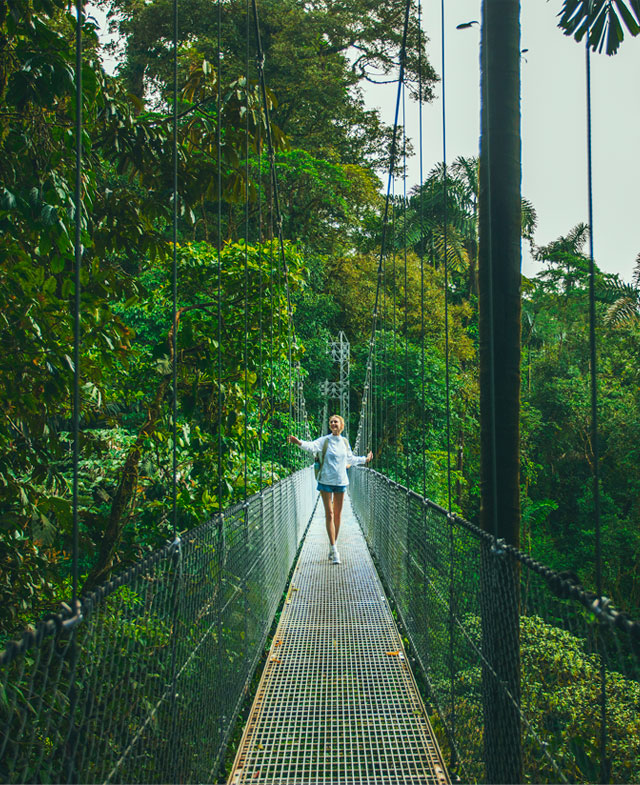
[585,27,610,783]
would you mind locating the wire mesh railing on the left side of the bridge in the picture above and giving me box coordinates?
[0,468,317,783]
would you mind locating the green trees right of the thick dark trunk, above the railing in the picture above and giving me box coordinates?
[521,224,640,615]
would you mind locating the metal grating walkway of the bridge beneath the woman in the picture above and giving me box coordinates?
[229,498,449,785]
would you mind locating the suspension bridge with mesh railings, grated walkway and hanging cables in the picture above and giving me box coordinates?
[0,0,640,785]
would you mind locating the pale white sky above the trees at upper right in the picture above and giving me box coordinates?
[367,0,640,281]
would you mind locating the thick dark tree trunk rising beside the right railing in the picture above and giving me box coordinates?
[478,0,522,783]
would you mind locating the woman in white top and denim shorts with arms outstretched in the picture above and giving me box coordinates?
[289,414,373,564]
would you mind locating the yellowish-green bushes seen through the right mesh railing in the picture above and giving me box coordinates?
[456,615,640,782]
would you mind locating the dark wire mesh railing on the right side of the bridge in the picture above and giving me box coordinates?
[350,468,640,783]
